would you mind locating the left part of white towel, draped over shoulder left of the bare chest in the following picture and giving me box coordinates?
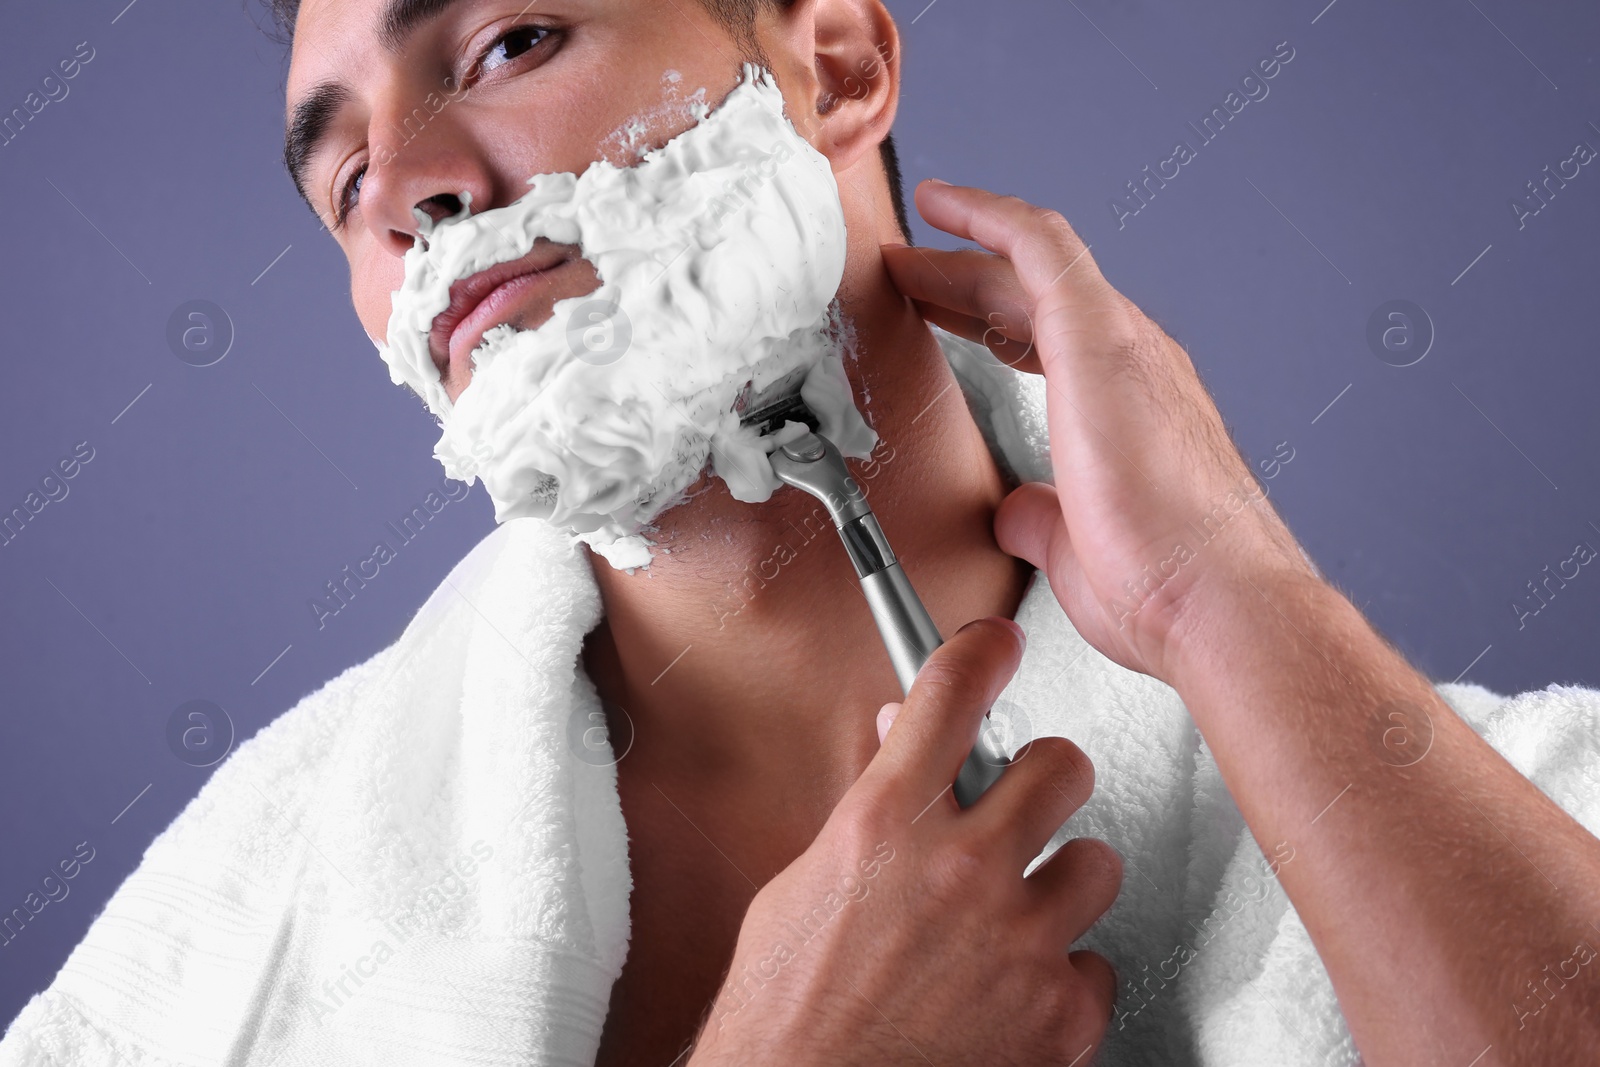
[0,502,632,1067]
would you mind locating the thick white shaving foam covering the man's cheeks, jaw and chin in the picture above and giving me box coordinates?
[378,66,877,568]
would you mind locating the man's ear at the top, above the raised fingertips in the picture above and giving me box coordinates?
[786,0,901,171]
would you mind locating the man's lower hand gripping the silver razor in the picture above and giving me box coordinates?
[690,617,1122,1067]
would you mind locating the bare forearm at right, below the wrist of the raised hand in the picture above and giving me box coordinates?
[1170,563,1600,1067]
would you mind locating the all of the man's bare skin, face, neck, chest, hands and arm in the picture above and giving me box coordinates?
[288,0,1600,1067]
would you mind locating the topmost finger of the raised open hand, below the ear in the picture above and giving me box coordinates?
[915,181,1110,306]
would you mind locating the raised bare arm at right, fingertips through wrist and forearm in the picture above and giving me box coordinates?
[885,175,1600,1067]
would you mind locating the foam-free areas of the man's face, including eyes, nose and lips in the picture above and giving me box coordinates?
[288,0,808,402]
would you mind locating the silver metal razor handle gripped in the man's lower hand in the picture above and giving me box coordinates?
[771,432,1011,808]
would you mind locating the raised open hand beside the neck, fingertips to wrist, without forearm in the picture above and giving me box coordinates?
[883,181,1320,683]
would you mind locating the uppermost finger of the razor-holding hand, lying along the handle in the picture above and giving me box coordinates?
[867,616,1024,817]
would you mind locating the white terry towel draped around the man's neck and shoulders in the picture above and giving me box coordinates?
[0,334,1600,1067]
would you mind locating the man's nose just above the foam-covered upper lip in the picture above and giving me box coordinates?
[360,88,494,258]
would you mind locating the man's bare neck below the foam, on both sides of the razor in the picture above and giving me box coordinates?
[584,247,1032,848]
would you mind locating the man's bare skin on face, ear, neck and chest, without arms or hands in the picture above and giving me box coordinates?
[288,0,1075,1062]
